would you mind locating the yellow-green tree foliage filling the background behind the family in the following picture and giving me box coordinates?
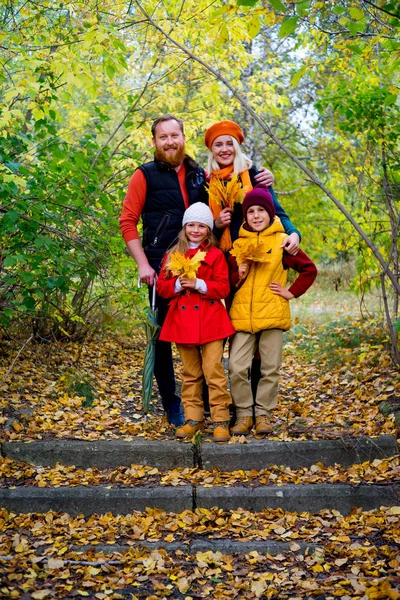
[0,0,400,364]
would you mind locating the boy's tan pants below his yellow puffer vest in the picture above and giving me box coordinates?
[229,329,283,417]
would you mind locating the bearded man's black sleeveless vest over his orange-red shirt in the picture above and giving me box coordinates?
[139,156,207,270]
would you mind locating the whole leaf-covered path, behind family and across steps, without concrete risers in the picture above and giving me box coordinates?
[0,304,400,600]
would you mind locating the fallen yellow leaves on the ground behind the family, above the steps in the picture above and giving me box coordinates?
[0,316,400,441]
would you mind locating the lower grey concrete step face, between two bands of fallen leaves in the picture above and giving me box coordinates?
[0,483,400,516]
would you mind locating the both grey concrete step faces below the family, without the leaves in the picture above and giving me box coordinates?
[0,435,400,516]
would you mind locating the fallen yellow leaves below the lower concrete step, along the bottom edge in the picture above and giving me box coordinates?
[0,507,400,600]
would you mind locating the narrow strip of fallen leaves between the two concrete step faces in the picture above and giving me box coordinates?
[0,456,400,487]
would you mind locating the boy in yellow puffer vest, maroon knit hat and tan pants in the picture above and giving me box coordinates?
[229,185,317,435]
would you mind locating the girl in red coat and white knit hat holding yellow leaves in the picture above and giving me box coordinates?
[157,202,235,442]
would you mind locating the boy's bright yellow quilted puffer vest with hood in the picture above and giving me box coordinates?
[229,217,290,333]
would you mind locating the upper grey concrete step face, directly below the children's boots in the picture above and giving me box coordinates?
[0,435,399,471]
